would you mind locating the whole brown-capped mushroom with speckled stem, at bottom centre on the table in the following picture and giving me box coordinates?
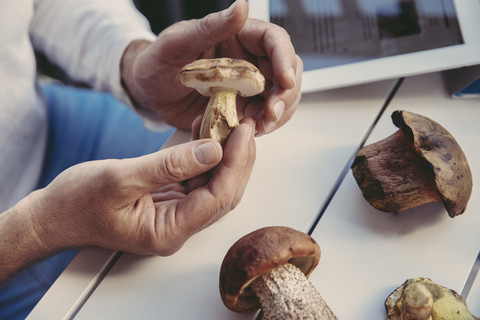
[220,227,337,320]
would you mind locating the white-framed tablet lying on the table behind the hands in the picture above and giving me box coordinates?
[249,0,480,92]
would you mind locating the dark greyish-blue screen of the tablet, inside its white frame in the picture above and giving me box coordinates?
[270,0,462,71]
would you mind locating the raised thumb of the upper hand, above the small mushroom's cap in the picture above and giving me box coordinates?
[159,0,248,62]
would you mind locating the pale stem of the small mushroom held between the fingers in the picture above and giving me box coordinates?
[200,87,239,143]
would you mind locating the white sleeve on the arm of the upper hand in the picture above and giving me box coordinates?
[30,0,168,130]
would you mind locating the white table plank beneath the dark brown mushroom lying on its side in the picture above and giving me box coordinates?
[311,74,480,320]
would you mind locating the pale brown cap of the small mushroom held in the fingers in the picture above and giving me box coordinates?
[179,58,265,97]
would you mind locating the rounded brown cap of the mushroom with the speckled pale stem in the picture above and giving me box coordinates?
[220,227,320,313]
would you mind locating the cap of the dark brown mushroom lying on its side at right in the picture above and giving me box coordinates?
[392,110,473,218]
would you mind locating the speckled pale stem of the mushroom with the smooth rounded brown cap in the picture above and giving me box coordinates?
[251,263,337,320]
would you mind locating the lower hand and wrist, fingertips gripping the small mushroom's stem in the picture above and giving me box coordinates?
[0,119,255,283]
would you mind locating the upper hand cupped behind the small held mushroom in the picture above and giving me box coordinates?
[121,0,303,135]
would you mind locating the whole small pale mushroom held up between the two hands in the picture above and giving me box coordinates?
[179,58,265,143]
